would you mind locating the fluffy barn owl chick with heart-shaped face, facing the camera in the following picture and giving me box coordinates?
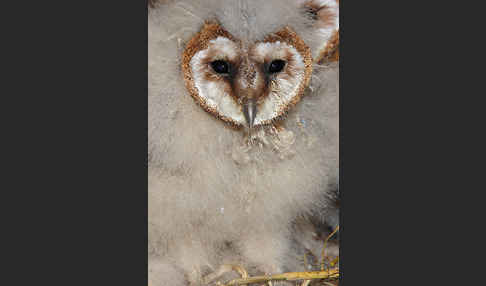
[148,0,339,286]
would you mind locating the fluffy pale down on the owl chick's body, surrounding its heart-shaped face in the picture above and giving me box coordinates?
[148,0,339,286]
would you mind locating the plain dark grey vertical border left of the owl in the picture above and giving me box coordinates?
[0,1,148,285]
